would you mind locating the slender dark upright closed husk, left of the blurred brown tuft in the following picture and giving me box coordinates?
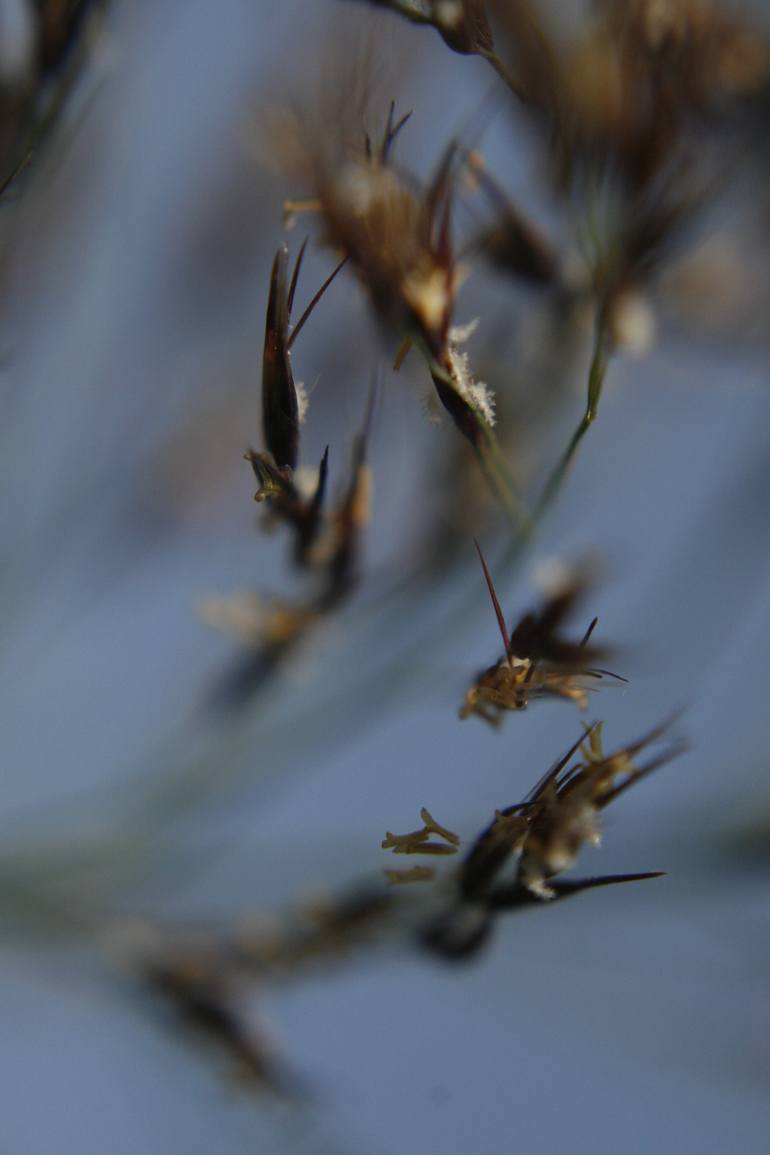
[262,246,299,470]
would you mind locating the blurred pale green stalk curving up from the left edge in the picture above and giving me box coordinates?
[0,519,535,931]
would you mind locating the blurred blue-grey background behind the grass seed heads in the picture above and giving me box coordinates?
[0,0,770,1155]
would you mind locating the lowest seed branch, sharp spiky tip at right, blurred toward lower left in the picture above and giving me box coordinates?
[111,723,679,1091]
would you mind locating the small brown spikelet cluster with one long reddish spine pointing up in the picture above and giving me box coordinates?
[459,543,625,725]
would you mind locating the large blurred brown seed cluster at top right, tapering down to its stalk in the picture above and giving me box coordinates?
[493,0,770,334]
